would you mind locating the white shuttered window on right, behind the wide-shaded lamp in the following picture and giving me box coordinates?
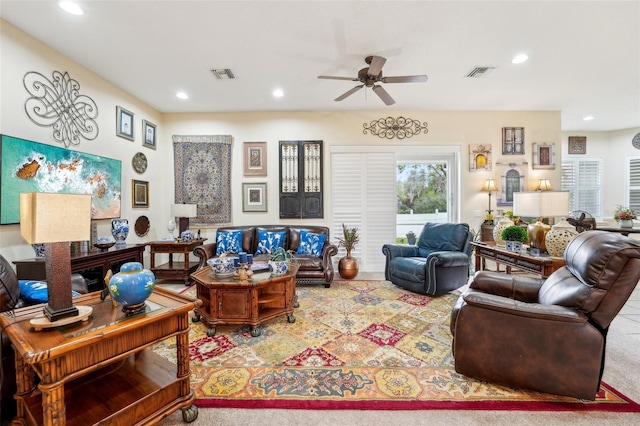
[561,158,602,218]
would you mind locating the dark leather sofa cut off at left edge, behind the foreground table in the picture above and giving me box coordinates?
[0,255,88,422]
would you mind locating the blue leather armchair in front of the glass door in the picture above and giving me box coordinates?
[382,223,473,296]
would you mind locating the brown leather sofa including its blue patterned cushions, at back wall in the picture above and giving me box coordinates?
[193,225,338,288]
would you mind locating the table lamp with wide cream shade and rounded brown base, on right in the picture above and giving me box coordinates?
[513,191,569,252]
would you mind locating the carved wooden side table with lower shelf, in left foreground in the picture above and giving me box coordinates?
[0,287,201,426]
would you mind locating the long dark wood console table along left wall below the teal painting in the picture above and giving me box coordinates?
[13,244,146,292]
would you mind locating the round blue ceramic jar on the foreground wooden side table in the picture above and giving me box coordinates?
[109,262,156,313]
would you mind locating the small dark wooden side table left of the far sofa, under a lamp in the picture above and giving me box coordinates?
[147,238,207,285]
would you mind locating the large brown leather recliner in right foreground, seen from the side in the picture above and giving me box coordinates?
[450,231,640,400]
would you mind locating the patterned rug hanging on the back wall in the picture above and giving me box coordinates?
[172,135,233,225]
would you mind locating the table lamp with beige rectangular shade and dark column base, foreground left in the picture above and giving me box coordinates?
[20,192,91,327]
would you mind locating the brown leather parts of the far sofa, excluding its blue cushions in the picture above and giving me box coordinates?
[193,225,338,288]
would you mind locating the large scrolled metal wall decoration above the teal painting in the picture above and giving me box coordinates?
[23,71,98,147]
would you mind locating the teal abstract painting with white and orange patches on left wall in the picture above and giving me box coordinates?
[0,135,122,225]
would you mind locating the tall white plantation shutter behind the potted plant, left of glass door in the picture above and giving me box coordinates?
[331,152,396,272]
